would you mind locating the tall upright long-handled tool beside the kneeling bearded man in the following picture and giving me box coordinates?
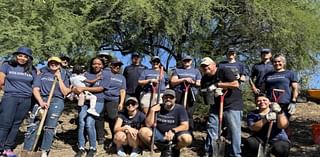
[150,66,163,156]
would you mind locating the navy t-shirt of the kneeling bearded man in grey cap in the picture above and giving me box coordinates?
[157,104,189,134]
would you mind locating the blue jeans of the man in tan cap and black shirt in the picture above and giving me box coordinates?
[205,108,242,157]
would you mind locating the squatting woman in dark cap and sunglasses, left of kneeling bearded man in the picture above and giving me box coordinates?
[113,97,146,157]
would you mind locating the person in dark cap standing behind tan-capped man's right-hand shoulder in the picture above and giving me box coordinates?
[218,48,246,82]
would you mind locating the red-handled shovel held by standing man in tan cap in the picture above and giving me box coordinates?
[212,90,228,157]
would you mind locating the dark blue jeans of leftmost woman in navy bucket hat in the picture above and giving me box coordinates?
[0,95,31,151]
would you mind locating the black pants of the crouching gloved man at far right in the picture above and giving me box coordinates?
[245,136,290,157]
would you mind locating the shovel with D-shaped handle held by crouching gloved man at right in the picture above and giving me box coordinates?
[257,89,285,157]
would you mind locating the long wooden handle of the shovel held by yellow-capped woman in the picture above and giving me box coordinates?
[32,77,57,151]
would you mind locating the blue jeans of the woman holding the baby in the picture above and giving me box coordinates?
[78,102,104,149]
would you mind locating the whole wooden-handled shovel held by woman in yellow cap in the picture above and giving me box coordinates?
[21,77,57,157]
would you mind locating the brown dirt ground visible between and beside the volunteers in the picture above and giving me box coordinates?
[15,102,320,157]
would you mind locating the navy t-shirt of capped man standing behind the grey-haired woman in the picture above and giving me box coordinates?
[251,61,273,89]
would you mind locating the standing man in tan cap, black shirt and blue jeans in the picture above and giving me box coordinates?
[201,57,243,157]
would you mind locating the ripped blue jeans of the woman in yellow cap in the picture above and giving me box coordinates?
[24,97,64,151]
